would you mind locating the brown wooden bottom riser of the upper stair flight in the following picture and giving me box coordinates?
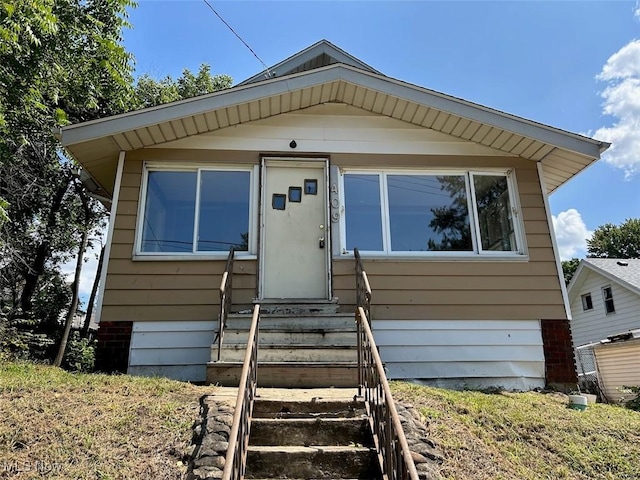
[207,361,358,388]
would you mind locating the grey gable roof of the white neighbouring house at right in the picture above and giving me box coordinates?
[567,258,640,301]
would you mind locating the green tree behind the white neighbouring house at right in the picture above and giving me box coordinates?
[587,218,640,258]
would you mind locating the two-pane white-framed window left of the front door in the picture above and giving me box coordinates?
[137,168,252,254]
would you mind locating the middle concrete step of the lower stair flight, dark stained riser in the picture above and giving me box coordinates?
[251,417,374,447]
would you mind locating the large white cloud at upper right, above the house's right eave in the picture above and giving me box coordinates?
[594,39,640,178]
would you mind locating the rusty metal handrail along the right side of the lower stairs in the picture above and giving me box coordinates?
[356,306,419,480]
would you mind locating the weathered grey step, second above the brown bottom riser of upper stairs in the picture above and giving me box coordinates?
[221,326,358,347]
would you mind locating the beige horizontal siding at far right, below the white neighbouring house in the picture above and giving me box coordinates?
[594,339,640,402]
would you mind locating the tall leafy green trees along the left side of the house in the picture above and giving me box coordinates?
[0,0,135,352]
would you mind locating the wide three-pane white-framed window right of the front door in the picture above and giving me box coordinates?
[342,170,522,255]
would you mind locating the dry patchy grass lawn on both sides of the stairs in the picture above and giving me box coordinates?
[0,363,640,480]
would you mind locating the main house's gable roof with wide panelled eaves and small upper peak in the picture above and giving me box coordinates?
[61,41,609,195]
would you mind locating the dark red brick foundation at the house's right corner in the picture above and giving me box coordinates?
[540,320,578,391]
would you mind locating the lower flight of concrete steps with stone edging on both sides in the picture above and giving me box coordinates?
[187,388,442,480]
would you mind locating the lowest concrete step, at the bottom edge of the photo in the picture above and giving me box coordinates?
[245,445,380,479]
